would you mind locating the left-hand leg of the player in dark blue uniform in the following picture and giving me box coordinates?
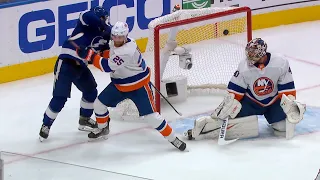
[39,59,77,140]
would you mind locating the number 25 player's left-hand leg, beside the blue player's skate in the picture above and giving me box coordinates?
[88,83,124,139]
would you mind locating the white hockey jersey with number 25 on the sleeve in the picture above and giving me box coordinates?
[93,38,150,92]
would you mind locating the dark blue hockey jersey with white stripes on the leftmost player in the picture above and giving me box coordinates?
[59,9,111,66]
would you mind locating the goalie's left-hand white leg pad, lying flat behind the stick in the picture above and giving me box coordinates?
[192,115,259,140]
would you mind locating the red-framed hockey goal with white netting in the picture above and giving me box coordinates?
[111,7,252,118]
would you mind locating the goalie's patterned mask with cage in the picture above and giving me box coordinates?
[245,38,268,65]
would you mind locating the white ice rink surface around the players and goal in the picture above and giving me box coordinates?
[0,21,320,180]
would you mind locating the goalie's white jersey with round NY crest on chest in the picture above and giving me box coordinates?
[228,53,296,106]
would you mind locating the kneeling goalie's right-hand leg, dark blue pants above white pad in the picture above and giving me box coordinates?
[264,99,287,137]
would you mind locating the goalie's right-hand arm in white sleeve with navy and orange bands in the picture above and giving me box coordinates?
[278,60,296,98]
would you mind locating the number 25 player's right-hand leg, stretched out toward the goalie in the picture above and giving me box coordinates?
[126,85,186,151]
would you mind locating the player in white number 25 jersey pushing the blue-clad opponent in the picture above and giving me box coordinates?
[79,22,186,151]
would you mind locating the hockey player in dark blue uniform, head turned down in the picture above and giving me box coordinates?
[39,6,111,141]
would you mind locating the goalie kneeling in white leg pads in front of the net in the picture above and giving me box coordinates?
[185,38,306,140]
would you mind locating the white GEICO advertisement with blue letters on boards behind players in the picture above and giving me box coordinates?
[0,0,181,66]
